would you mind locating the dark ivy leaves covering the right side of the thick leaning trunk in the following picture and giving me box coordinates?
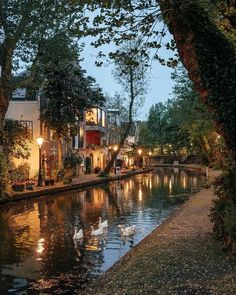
[186,3,236,151]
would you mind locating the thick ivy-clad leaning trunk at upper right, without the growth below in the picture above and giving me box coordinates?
[159,0,236,157]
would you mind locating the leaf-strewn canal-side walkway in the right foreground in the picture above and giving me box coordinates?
[84,171,236,295]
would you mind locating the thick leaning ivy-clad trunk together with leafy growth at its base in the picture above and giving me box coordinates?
[159,0,236,252]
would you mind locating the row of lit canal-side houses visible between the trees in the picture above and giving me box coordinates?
[7,85,141,177]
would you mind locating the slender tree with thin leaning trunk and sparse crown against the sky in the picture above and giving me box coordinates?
[104,42,147,173]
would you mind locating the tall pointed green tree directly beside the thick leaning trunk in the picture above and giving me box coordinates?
[168,67,217,162]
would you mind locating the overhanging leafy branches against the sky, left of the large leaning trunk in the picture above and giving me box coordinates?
[84,1,177,67]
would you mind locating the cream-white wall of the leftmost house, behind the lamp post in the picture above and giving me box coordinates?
[6,101,40,177]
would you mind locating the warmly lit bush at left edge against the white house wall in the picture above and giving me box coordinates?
[0,119,31,160]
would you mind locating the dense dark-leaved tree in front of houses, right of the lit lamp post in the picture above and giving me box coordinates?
[39,38,104,169]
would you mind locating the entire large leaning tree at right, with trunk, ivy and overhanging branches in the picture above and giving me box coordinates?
[85,0,236,249]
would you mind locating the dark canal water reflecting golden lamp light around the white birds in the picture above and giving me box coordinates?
[0,168,202,295]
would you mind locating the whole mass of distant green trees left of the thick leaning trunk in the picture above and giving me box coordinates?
[139,67,217,162]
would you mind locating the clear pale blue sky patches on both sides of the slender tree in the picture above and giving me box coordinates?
[81,37,173,120]
